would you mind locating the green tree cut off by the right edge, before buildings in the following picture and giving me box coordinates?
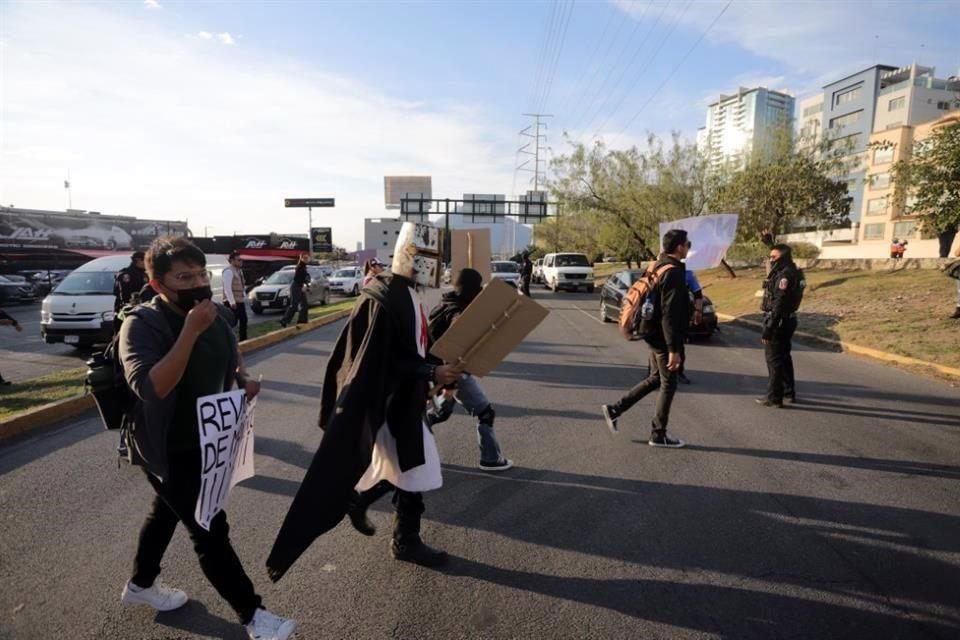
[891,120,960,234]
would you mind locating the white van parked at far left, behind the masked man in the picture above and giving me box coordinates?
[40,254,228,347]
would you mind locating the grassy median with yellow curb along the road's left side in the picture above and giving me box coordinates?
[0,301,353,442]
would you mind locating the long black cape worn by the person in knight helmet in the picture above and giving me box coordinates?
[267,275,434,582]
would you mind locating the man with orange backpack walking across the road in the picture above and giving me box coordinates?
[601,229,691,449]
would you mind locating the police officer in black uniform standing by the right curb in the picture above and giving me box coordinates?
[757,244,806,408]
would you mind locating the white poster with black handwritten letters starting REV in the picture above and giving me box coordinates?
[194,389,257,531]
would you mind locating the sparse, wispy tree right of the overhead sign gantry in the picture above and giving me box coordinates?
[537,133,707,268]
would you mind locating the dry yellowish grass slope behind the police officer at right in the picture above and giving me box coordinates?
[697,269,960,367]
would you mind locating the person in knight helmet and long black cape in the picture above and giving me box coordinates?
[267,222,461,581]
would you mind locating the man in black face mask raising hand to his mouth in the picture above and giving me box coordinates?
[120,237,296,640]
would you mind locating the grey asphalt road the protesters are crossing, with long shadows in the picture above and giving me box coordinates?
[0,289,960,640]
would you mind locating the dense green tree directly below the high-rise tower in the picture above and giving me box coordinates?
[710,128,852,240]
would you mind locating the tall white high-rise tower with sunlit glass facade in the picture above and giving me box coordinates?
[697,87,794,170]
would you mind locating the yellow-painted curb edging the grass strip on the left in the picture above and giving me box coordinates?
[0,309,350,442]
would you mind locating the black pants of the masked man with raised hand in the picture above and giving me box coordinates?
[132,449,261,624]
